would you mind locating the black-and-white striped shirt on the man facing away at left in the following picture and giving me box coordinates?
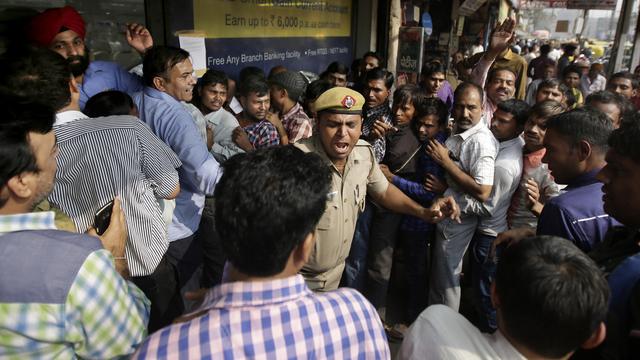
[49,111,180,276]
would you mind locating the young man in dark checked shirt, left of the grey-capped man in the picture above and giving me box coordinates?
[231,78,284,151]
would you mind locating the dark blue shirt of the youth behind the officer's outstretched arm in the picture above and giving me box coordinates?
[392,132,447,232]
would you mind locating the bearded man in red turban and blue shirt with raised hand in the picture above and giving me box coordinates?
[26,6,153,108]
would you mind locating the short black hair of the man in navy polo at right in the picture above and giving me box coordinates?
[547,106,613,153]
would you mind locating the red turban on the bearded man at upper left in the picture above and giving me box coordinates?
[27,6,85,47]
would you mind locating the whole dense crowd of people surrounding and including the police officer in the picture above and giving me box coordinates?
[0,6,640,359]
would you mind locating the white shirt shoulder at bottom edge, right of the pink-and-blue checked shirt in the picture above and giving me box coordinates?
[396,305,526,360]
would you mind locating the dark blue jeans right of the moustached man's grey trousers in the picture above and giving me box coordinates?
[471,233,497,333]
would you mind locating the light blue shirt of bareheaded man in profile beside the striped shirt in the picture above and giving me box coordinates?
[133,86,222,241]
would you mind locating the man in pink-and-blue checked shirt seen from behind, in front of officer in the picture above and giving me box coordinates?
[133,146,390,359]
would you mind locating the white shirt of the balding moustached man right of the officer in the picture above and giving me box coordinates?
[445,119,498,215]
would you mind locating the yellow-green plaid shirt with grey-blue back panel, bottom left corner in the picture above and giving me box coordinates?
[0,211,149,359]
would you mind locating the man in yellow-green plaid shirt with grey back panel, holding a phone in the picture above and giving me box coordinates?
[0,95,150,359]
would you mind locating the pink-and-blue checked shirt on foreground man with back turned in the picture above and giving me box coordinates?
[133,275,390,359]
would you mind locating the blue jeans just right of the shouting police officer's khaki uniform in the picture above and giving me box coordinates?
[340,201,375,292]
